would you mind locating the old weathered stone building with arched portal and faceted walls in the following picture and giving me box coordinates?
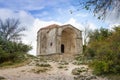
[37,24,82,56]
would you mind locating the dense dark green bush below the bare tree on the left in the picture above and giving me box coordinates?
[0,38,31,63]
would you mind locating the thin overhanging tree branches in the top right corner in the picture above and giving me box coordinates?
[80,0,120,19]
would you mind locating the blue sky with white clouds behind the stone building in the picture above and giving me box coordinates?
[0,0,120,55]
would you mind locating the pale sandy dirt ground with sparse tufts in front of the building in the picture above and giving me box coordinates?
[0,57,107,80]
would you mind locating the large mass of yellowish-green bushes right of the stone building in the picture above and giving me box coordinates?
[85,26,120,75]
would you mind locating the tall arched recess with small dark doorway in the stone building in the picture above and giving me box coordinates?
[61,28,76,54]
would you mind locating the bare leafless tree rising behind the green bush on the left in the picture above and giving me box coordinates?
[0,18,26,41]
